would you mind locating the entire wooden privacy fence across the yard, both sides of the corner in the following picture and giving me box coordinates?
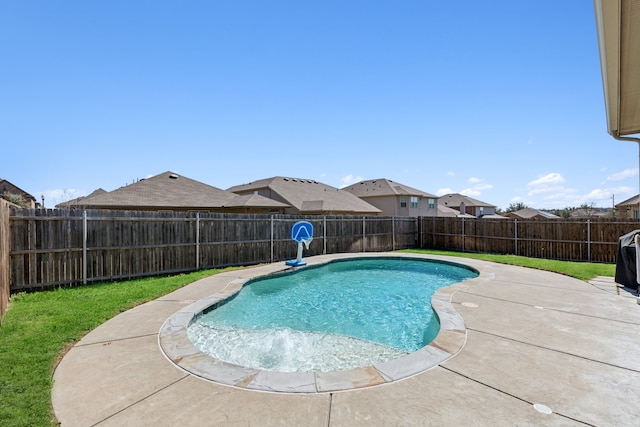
[7,208,640,294]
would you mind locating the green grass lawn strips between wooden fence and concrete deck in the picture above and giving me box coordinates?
[0,250,615,427]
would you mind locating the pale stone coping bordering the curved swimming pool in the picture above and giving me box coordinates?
[158,253,490,393]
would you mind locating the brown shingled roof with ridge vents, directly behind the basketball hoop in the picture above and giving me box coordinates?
[227,176,381,214]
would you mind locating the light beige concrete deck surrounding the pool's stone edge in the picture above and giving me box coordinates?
[52,253,640,427]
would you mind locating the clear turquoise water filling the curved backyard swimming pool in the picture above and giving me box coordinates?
[187,258,477,372]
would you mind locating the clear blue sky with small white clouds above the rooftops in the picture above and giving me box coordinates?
[0,0,638,209]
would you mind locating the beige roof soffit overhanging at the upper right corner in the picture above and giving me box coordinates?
[594,0,640,136]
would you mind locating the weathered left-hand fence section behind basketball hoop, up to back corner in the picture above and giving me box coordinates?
[9,209,418,292]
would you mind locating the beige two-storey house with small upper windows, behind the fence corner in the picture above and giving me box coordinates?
[342,178,438,217]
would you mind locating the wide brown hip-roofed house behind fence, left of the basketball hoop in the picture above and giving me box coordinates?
[56,172,288,213]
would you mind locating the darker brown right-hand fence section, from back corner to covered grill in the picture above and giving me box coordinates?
[419,217,640,263]
